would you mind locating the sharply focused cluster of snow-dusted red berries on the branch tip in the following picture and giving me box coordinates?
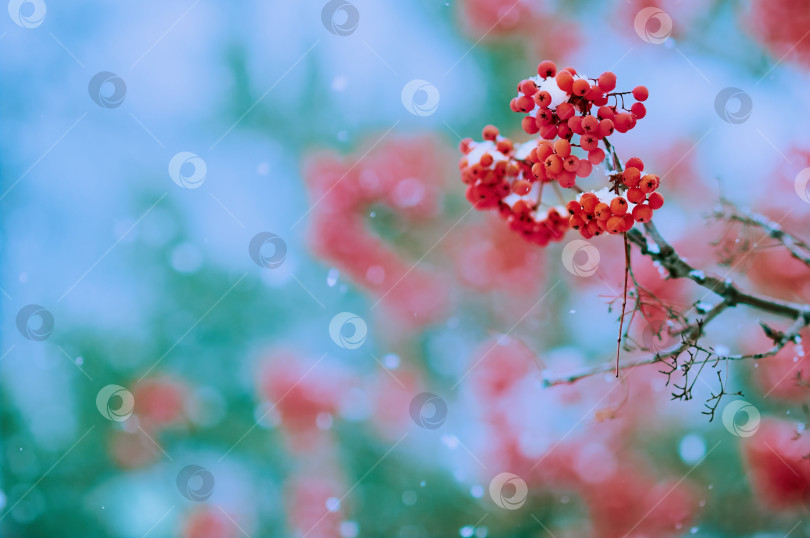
[459,61,664,245]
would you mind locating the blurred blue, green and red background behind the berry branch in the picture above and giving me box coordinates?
[0,0,810,538]
